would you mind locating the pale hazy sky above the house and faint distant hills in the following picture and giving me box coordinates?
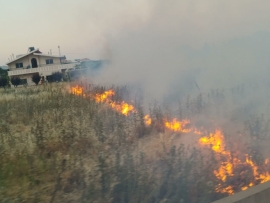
[0,0,270,65]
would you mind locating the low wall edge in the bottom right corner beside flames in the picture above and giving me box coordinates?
[212,182,270,203]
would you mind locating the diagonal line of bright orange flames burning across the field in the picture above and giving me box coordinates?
[70,85,270,195]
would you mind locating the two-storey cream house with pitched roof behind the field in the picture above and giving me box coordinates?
[7,47,77,85]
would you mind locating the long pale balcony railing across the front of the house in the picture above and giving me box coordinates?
[8,63,78,76]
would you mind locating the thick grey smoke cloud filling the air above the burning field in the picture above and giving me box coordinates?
[83,1,270,104]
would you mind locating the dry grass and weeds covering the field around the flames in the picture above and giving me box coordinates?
[0,84,269,203]
